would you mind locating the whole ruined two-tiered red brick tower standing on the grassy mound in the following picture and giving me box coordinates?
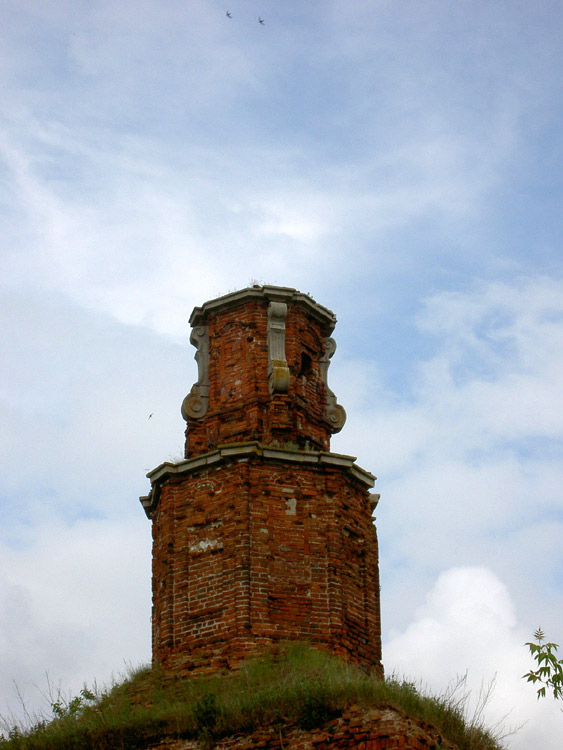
[141,286,382,673]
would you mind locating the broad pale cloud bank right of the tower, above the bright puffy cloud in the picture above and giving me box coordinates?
[331,276,563,680]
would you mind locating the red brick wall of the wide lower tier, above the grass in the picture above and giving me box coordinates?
[153,457,381,670]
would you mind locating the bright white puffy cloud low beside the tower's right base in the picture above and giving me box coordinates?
[384,567,561,750]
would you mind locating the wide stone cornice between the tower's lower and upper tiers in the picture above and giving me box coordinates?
[139,442,379,518]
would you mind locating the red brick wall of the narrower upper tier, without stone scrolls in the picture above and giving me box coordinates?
[185,300,331,458]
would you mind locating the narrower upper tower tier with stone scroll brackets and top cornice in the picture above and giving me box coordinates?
[182,286,346,458]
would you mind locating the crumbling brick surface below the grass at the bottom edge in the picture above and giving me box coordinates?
[145,707,456,750]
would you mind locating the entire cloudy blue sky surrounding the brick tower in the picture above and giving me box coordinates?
[0,0,563,750]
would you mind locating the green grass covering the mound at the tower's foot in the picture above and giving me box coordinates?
[0,644,503,750]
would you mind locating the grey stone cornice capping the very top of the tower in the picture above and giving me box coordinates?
[190,285,336,336]
